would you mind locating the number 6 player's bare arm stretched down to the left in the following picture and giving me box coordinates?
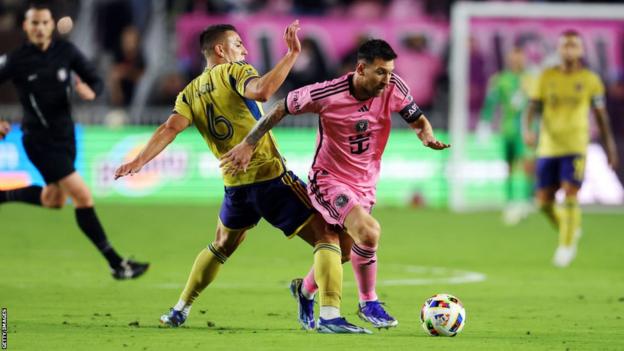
[115,113,191,179]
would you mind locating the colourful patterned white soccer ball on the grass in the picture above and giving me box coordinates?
[420,294,466,336]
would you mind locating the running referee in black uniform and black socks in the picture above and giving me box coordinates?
[0,5,149,279]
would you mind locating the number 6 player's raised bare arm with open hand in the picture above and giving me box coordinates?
[244,20,301,102]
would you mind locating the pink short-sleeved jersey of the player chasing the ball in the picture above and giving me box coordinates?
[286,73,422,198]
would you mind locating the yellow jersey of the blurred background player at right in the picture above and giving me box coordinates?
[531,67,605,157]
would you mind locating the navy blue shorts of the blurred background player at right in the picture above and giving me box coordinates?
[535,155,585,189]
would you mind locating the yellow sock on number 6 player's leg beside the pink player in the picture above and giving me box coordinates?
[314,243,342,308]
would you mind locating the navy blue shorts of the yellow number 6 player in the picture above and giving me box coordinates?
[219,171,314,236]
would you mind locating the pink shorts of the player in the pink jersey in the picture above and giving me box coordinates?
[308,171,375,226]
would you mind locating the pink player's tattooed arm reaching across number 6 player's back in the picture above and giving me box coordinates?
[219,99,287,174]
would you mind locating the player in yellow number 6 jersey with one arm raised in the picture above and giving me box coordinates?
[115,21,370,333]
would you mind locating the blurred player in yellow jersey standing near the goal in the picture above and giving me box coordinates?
[523,30,618,267]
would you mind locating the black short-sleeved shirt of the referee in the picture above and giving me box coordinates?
[0,40,103,139]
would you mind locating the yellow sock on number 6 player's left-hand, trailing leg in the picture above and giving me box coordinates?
[180,244,227,305]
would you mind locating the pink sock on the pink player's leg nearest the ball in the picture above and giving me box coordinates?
[351,244,377,301]
